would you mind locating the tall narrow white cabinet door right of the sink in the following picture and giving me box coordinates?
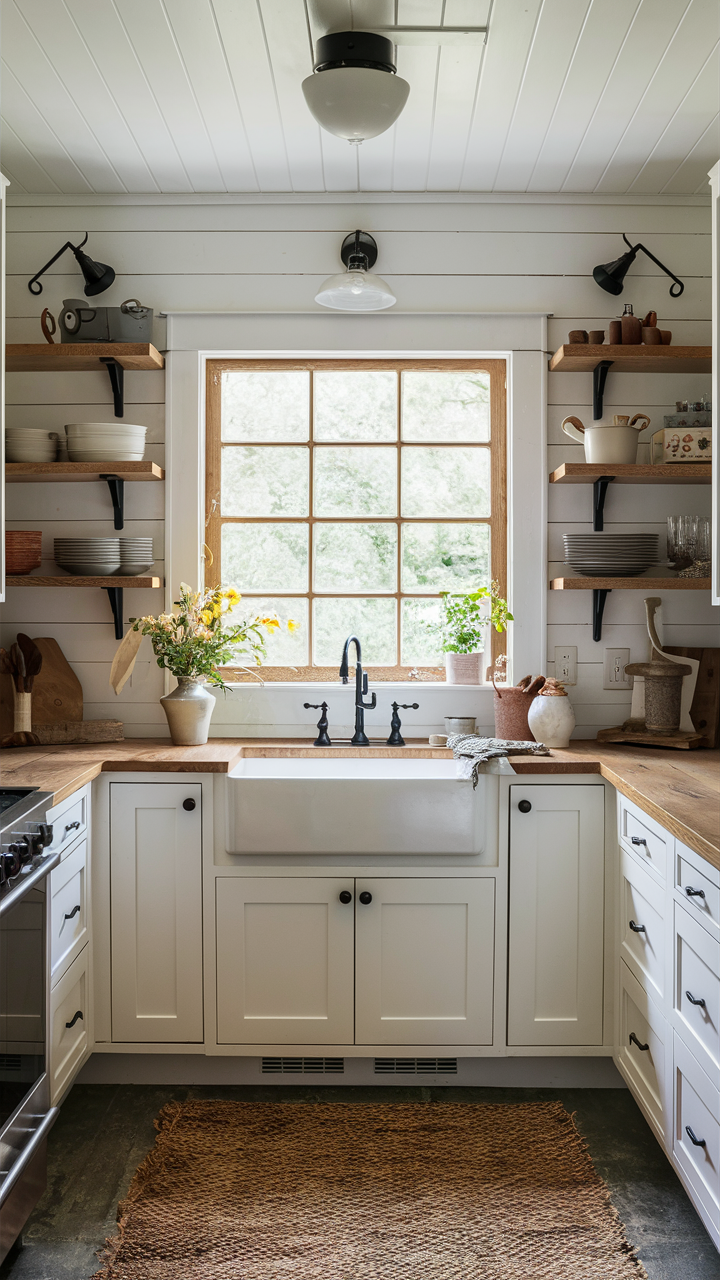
[507,786,605,1046]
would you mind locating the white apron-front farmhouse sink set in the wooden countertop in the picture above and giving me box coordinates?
[227,756,486,855]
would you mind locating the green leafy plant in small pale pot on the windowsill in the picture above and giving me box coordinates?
[433,582,514,685]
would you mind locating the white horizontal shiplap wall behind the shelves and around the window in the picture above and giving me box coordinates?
[3,185,720,737]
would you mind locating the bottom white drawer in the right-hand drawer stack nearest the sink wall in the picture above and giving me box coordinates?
[618,961,669,1142]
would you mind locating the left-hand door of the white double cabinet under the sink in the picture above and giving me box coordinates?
[215,876,355,1044]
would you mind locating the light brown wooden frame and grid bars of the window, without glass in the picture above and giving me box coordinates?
[204,358,507,684]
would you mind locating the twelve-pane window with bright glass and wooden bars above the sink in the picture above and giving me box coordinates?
[205,360,506,680]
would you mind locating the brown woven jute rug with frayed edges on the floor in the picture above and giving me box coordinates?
[95,1102,646,1280]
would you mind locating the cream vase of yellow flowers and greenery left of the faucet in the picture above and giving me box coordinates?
[110,582,296,746]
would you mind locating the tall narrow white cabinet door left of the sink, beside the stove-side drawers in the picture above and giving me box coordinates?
[110,782,202,1044]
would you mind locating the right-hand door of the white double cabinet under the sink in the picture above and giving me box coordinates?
[355,878,495,1044]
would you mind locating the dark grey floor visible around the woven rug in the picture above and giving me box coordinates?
[0,1084,720,1280]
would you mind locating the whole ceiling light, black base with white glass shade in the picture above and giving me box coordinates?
[302,31,410,143]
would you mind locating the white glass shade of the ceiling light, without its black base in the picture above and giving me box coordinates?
[302,67,410,142]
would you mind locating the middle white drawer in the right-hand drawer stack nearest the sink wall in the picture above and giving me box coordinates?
[620,854,665,1002]
